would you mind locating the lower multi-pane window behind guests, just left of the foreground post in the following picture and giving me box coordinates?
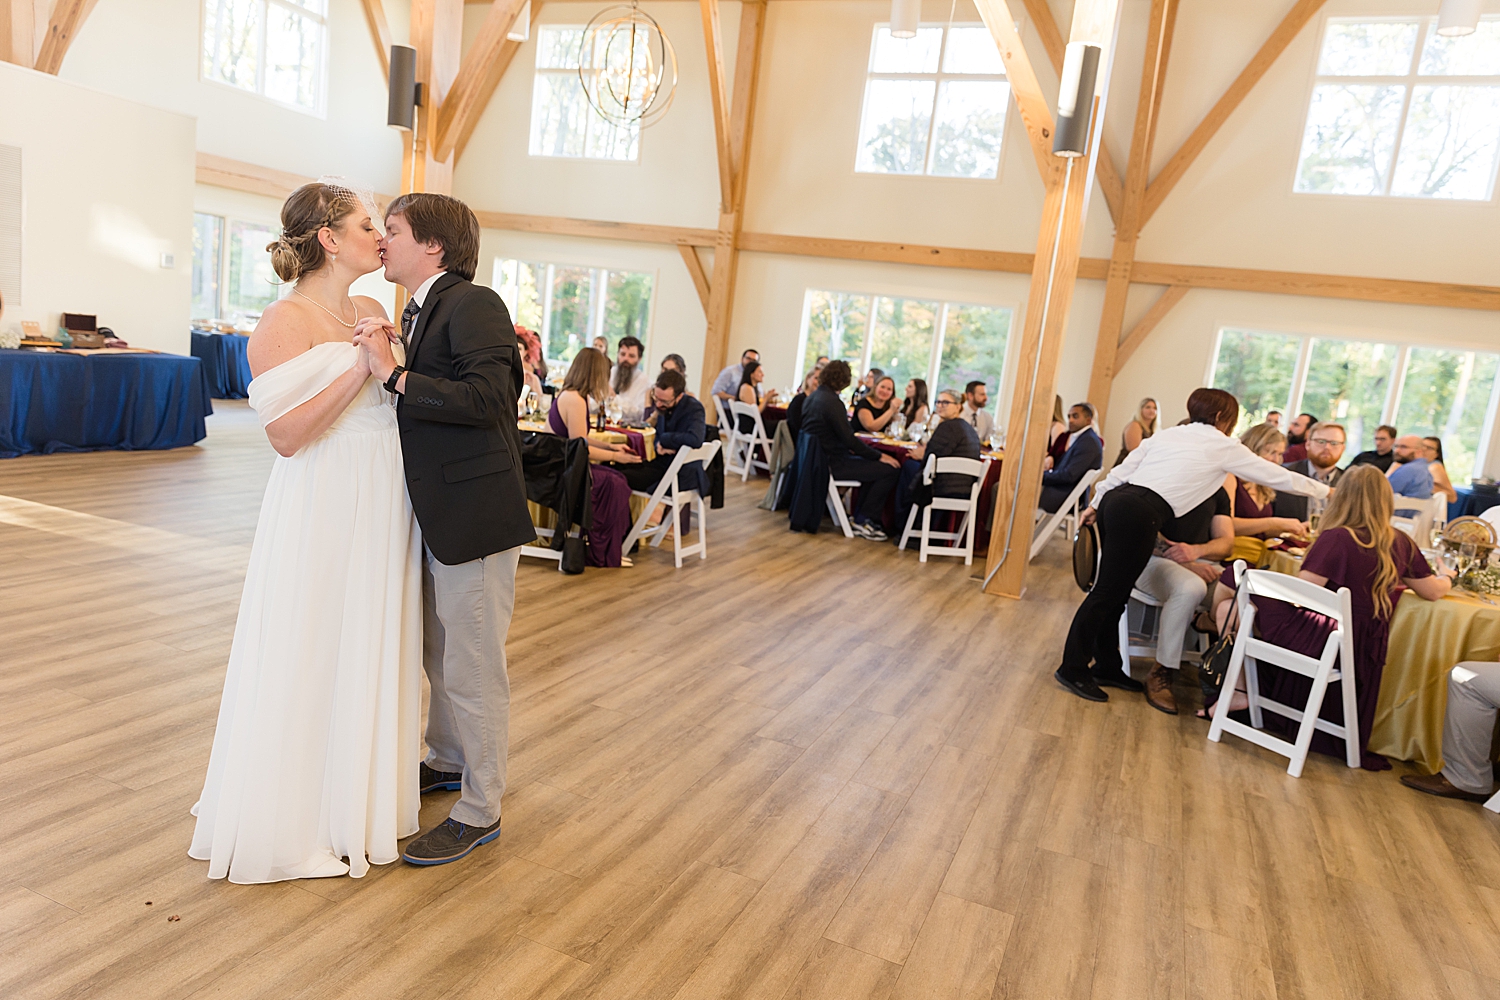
[797,289,1011,413]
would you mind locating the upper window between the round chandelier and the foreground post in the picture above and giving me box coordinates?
[855,24,1011,177]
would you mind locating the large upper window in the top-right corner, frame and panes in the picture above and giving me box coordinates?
[1296,18,1500,201]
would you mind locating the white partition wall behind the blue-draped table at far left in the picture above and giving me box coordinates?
[0,63,194,354]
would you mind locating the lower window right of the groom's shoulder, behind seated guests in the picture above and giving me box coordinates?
[494,259,654,361]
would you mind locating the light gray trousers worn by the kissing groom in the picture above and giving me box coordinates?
[422,546,521,826]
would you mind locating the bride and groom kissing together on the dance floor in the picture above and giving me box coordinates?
[188,181,534,883]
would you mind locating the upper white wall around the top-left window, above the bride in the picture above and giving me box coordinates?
[60,0,411,194]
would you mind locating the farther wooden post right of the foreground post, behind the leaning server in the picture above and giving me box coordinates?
[1089,0,1178,427]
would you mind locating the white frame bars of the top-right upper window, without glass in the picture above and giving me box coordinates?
[1292,13,1500,205]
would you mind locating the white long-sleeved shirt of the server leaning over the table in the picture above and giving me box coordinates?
[1091,424,1329,517]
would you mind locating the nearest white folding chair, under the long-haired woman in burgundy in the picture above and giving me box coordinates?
[1209,570,1359,778]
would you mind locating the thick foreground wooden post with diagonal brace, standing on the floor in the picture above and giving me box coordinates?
[980,0,1119,598]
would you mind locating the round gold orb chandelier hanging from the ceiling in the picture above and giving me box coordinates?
[578,3,677,129]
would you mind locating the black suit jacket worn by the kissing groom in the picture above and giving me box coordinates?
[396,274,536,565]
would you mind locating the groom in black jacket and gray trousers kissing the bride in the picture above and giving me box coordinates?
[354,193,536,865]
